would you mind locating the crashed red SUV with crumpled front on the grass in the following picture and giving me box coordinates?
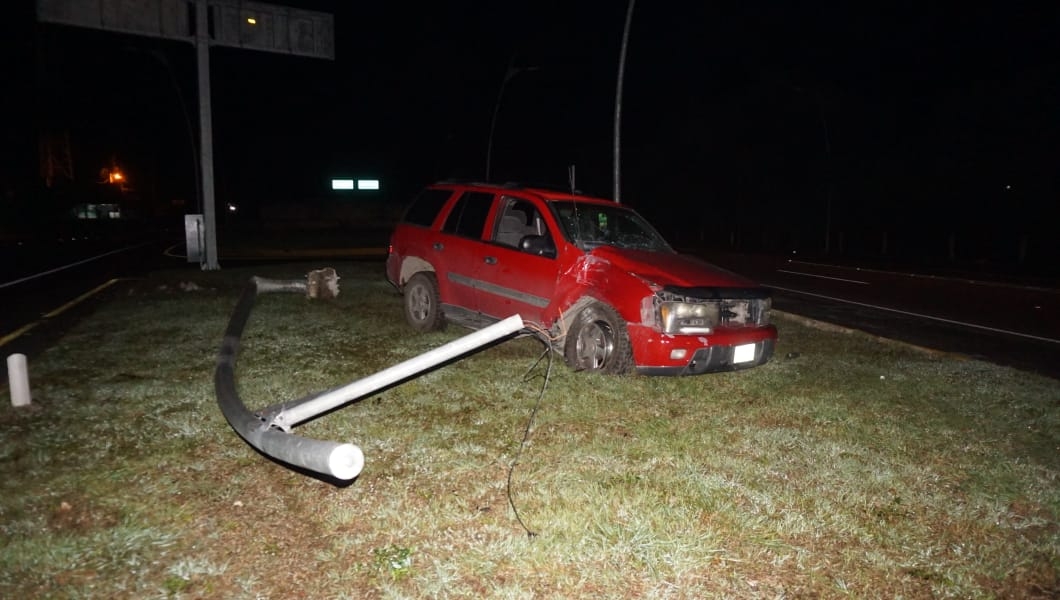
[387,182,777,375]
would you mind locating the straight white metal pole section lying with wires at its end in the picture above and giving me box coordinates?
[270,315,523,429]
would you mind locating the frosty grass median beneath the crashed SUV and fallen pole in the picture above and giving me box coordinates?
[0,262,1060,598]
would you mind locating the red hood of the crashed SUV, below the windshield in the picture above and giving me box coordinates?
[590,246,758,287]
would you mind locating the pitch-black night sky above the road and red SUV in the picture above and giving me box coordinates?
[4,0,1060,262]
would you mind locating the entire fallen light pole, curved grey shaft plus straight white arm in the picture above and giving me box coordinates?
[214,271,523,479]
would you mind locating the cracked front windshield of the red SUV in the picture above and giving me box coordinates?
[552,201,673,252]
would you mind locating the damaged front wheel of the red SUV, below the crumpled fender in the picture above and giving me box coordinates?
[563,302,633,374]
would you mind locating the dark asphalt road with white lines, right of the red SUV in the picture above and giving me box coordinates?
[706,254,1060,380]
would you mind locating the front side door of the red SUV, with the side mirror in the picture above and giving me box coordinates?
[474,195,558,324]
